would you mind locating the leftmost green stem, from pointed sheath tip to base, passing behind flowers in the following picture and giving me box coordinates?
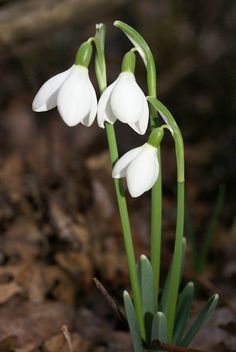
[94,24,145,340]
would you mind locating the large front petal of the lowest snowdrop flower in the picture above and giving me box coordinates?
[126,143,159,197]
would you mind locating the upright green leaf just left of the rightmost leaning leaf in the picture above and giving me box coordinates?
[173,282,194,344]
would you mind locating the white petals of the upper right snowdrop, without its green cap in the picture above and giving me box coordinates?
[98,71,149,134]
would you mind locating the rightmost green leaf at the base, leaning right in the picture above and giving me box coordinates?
[180,294,219,347]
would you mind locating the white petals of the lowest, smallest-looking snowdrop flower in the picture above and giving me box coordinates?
[112,143,159,197]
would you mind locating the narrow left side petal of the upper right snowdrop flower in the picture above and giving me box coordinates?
[97,80,117,128]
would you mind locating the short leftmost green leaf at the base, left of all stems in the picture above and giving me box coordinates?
[123,291,144,352]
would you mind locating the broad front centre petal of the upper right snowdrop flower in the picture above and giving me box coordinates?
[110,72,145,123]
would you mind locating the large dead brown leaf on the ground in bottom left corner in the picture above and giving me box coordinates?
[0,299,73,348]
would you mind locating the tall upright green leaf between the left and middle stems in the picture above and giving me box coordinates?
[138,254,155,341]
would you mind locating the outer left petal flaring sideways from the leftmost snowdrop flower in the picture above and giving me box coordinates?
[32,67,71,112]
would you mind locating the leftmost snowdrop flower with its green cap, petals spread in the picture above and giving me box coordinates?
[32,41,97,126]
